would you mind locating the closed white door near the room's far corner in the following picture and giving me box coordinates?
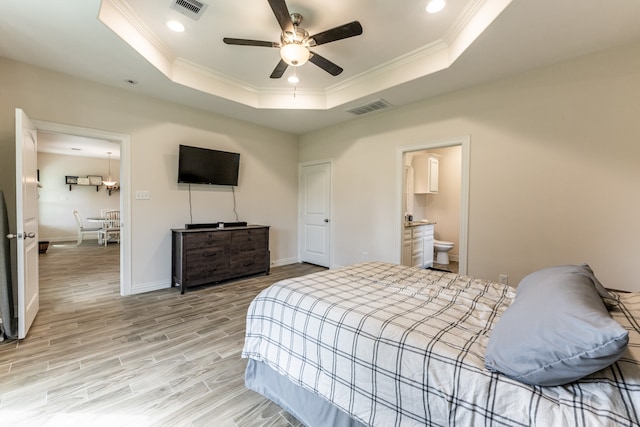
[299,163,331,267]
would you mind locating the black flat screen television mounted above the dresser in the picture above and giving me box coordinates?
[178,145,240,186]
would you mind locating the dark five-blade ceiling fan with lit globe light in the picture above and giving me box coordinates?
[222,0,362,79]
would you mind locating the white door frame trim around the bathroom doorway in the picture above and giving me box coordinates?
[396,135,471,275]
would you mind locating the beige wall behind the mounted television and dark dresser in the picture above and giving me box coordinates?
[0,58,298,292]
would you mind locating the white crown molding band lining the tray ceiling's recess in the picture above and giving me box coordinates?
[98,0,512,110]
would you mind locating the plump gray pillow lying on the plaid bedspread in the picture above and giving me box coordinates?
[485,265,629,386]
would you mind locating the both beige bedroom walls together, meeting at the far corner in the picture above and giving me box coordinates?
[0,40,640,290]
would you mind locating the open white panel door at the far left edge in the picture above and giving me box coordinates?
[16,108,40,339]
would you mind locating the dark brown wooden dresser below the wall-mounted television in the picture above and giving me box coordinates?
[171,225,271,293]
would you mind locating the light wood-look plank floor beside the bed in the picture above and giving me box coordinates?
[0,241,322,427]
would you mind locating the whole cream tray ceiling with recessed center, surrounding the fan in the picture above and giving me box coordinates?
[0,0,640,134]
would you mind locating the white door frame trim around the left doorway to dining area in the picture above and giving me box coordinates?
[32,120,131,296]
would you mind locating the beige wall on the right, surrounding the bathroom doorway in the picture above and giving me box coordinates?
[300,40,640,291]
